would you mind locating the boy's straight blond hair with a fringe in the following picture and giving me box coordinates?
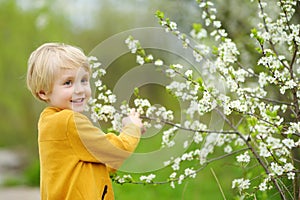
[27,43,90,101]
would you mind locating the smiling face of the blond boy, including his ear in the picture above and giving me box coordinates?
[45,67,91,112]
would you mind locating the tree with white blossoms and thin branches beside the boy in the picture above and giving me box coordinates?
[90,0,300,199]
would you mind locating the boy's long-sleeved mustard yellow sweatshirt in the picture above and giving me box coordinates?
[38,107,141,200]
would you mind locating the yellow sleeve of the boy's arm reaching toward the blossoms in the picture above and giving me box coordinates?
[68,113,141,169]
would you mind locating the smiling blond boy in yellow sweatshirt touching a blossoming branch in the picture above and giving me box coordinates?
[27,43,143,200]
